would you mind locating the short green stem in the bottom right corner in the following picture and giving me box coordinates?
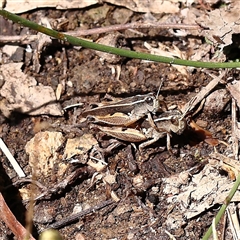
[202,174,240,240]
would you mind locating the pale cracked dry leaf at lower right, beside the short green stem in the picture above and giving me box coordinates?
[163,165,240,219]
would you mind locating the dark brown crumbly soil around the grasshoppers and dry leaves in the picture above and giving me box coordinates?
[0,5,237,239]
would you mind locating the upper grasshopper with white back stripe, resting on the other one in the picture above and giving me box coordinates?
[82,93,166,127]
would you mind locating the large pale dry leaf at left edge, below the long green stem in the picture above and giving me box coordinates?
[0,63,63,117]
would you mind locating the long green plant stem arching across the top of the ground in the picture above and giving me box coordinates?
[0,10,240,68]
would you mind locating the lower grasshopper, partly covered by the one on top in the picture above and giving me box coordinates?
[92,110,187,152]
